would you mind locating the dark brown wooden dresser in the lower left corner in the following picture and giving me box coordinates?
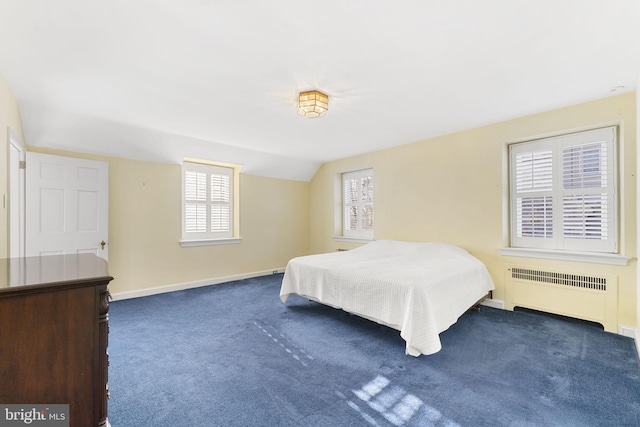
[0,254,113,427]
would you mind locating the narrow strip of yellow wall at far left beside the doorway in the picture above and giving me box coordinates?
[0,76,24,258]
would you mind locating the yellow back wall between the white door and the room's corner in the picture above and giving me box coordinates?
[29,147,309,294]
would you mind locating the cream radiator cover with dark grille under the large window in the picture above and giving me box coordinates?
[505,265,618,332]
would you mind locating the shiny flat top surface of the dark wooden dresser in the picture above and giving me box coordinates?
[0,254,113,293]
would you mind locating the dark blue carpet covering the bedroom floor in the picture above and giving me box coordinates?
[109,275,640,427]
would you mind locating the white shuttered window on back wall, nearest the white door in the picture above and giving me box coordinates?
[182,162,234,240]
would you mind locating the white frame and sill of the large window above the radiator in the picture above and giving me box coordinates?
[500,124,630,265]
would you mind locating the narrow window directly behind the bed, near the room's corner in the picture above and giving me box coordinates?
[342,169,373,239]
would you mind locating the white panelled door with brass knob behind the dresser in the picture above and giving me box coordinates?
[25,152,109,260]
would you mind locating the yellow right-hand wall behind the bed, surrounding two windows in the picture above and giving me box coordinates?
[310,93,636,326]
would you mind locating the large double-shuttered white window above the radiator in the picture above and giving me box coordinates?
[509,127,618,253]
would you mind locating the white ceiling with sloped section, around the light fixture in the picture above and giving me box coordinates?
[0,0,640,180]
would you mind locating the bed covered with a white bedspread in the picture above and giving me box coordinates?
[280,240,494,357]
